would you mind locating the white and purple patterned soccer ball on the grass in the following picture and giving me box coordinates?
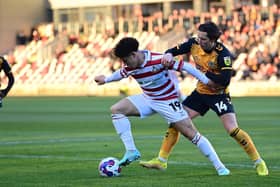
[98,157,121,177]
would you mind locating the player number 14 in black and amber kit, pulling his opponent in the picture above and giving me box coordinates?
[140,22,268,176]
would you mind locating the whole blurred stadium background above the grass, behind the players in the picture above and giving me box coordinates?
[0,0,280,96]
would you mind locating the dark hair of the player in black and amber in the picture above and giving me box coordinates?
[198,21,222,41]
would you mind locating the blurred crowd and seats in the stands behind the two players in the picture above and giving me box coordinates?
[1,5,280,87]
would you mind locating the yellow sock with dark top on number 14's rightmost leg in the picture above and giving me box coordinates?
[230,128,260,161]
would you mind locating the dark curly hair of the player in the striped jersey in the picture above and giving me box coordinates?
[114,37,139,58]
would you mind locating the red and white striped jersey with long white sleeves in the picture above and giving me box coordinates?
[105,50,209,100]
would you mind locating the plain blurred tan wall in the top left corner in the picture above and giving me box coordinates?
[0,0,52,54]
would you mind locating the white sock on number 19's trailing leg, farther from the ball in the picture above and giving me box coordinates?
[192,133,225,170]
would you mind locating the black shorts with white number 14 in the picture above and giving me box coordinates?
[182,90,234,116]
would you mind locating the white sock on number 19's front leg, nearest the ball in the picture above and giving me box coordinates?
[112,114,136,151]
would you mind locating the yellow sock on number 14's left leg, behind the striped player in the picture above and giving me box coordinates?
[158,127,180,160]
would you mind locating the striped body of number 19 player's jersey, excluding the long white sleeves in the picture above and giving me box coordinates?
[120,50,183,100]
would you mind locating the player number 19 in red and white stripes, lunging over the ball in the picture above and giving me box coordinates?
[95,37,230,175]
